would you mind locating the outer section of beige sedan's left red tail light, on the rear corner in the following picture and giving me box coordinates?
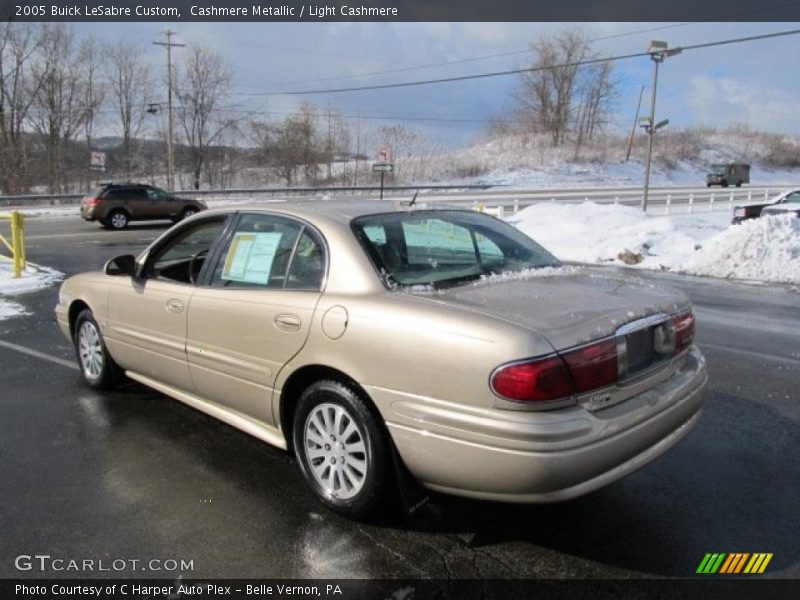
[491,356,575,402]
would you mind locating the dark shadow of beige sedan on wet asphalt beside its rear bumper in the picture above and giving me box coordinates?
[400,395,800,577]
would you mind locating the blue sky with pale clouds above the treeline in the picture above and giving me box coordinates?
[74,22,800,145]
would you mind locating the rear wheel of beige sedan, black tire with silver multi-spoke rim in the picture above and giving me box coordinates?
[292,381,394,520]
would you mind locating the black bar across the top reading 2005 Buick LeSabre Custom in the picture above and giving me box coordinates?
[0,0,800,22]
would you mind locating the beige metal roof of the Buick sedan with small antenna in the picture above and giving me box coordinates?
[203,198,468,223]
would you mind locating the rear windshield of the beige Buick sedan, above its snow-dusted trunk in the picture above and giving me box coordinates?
[352,210,559,287]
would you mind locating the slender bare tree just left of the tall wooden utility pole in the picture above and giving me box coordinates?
[106,39,150,177]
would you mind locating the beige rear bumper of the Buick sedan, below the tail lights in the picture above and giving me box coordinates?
[380,348,708,502]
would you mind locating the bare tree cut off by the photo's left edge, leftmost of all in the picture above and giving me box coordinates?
[0,23,42,194]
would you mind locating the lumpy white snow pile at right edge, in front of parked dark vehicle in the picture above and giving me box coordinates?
[683,215,800,283]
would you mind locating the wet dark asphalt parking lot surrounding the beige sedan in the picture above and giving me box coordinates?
[0,217,800,578]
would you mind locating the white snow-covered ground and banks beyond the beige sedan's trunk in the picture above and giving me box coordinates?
[509,202,800,284]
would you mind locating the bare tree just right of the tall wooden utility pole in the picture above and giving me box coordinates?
[176,47,234,189]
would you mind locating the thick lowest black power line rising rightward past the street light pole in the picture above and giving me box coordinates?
[254,29,800,96]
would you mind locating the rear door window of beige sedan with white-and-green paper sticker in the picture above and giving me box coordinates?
[211,215,325,289]
